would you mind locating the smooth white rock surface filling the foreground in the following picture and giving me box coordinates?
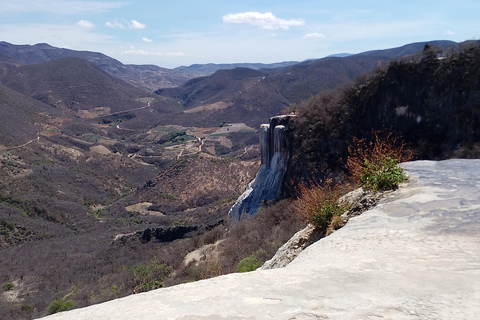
[41,160,480,320]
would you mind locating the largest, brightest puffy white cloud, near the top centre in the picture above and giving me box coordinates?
[222,11,305,30]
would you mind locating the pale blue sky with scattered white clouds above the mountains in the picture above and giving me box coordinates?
[0,0,480,68]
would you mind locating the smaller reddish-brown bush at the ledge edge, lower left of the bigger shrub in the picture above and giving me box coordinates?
[294,180,347,232]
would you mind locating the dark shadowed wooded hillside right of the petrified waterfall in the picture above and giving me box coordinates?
[286,43,480,190]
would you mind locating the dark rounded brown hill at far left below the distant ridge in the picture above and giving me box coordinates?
[1,58,153,112]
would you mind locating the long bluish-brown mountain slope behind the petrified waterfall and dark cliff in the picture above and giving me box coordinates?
[156,41,454,127]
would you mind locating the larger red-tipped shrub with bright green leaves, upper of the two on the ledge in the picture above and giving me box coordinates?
[346,131,412,191]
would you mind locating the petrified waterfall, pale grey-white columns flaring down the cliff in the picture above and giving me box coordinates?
[228,115,292,220]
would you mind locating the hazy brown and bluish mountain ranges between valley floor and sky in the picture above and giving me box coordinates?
[0,41,455,128]
